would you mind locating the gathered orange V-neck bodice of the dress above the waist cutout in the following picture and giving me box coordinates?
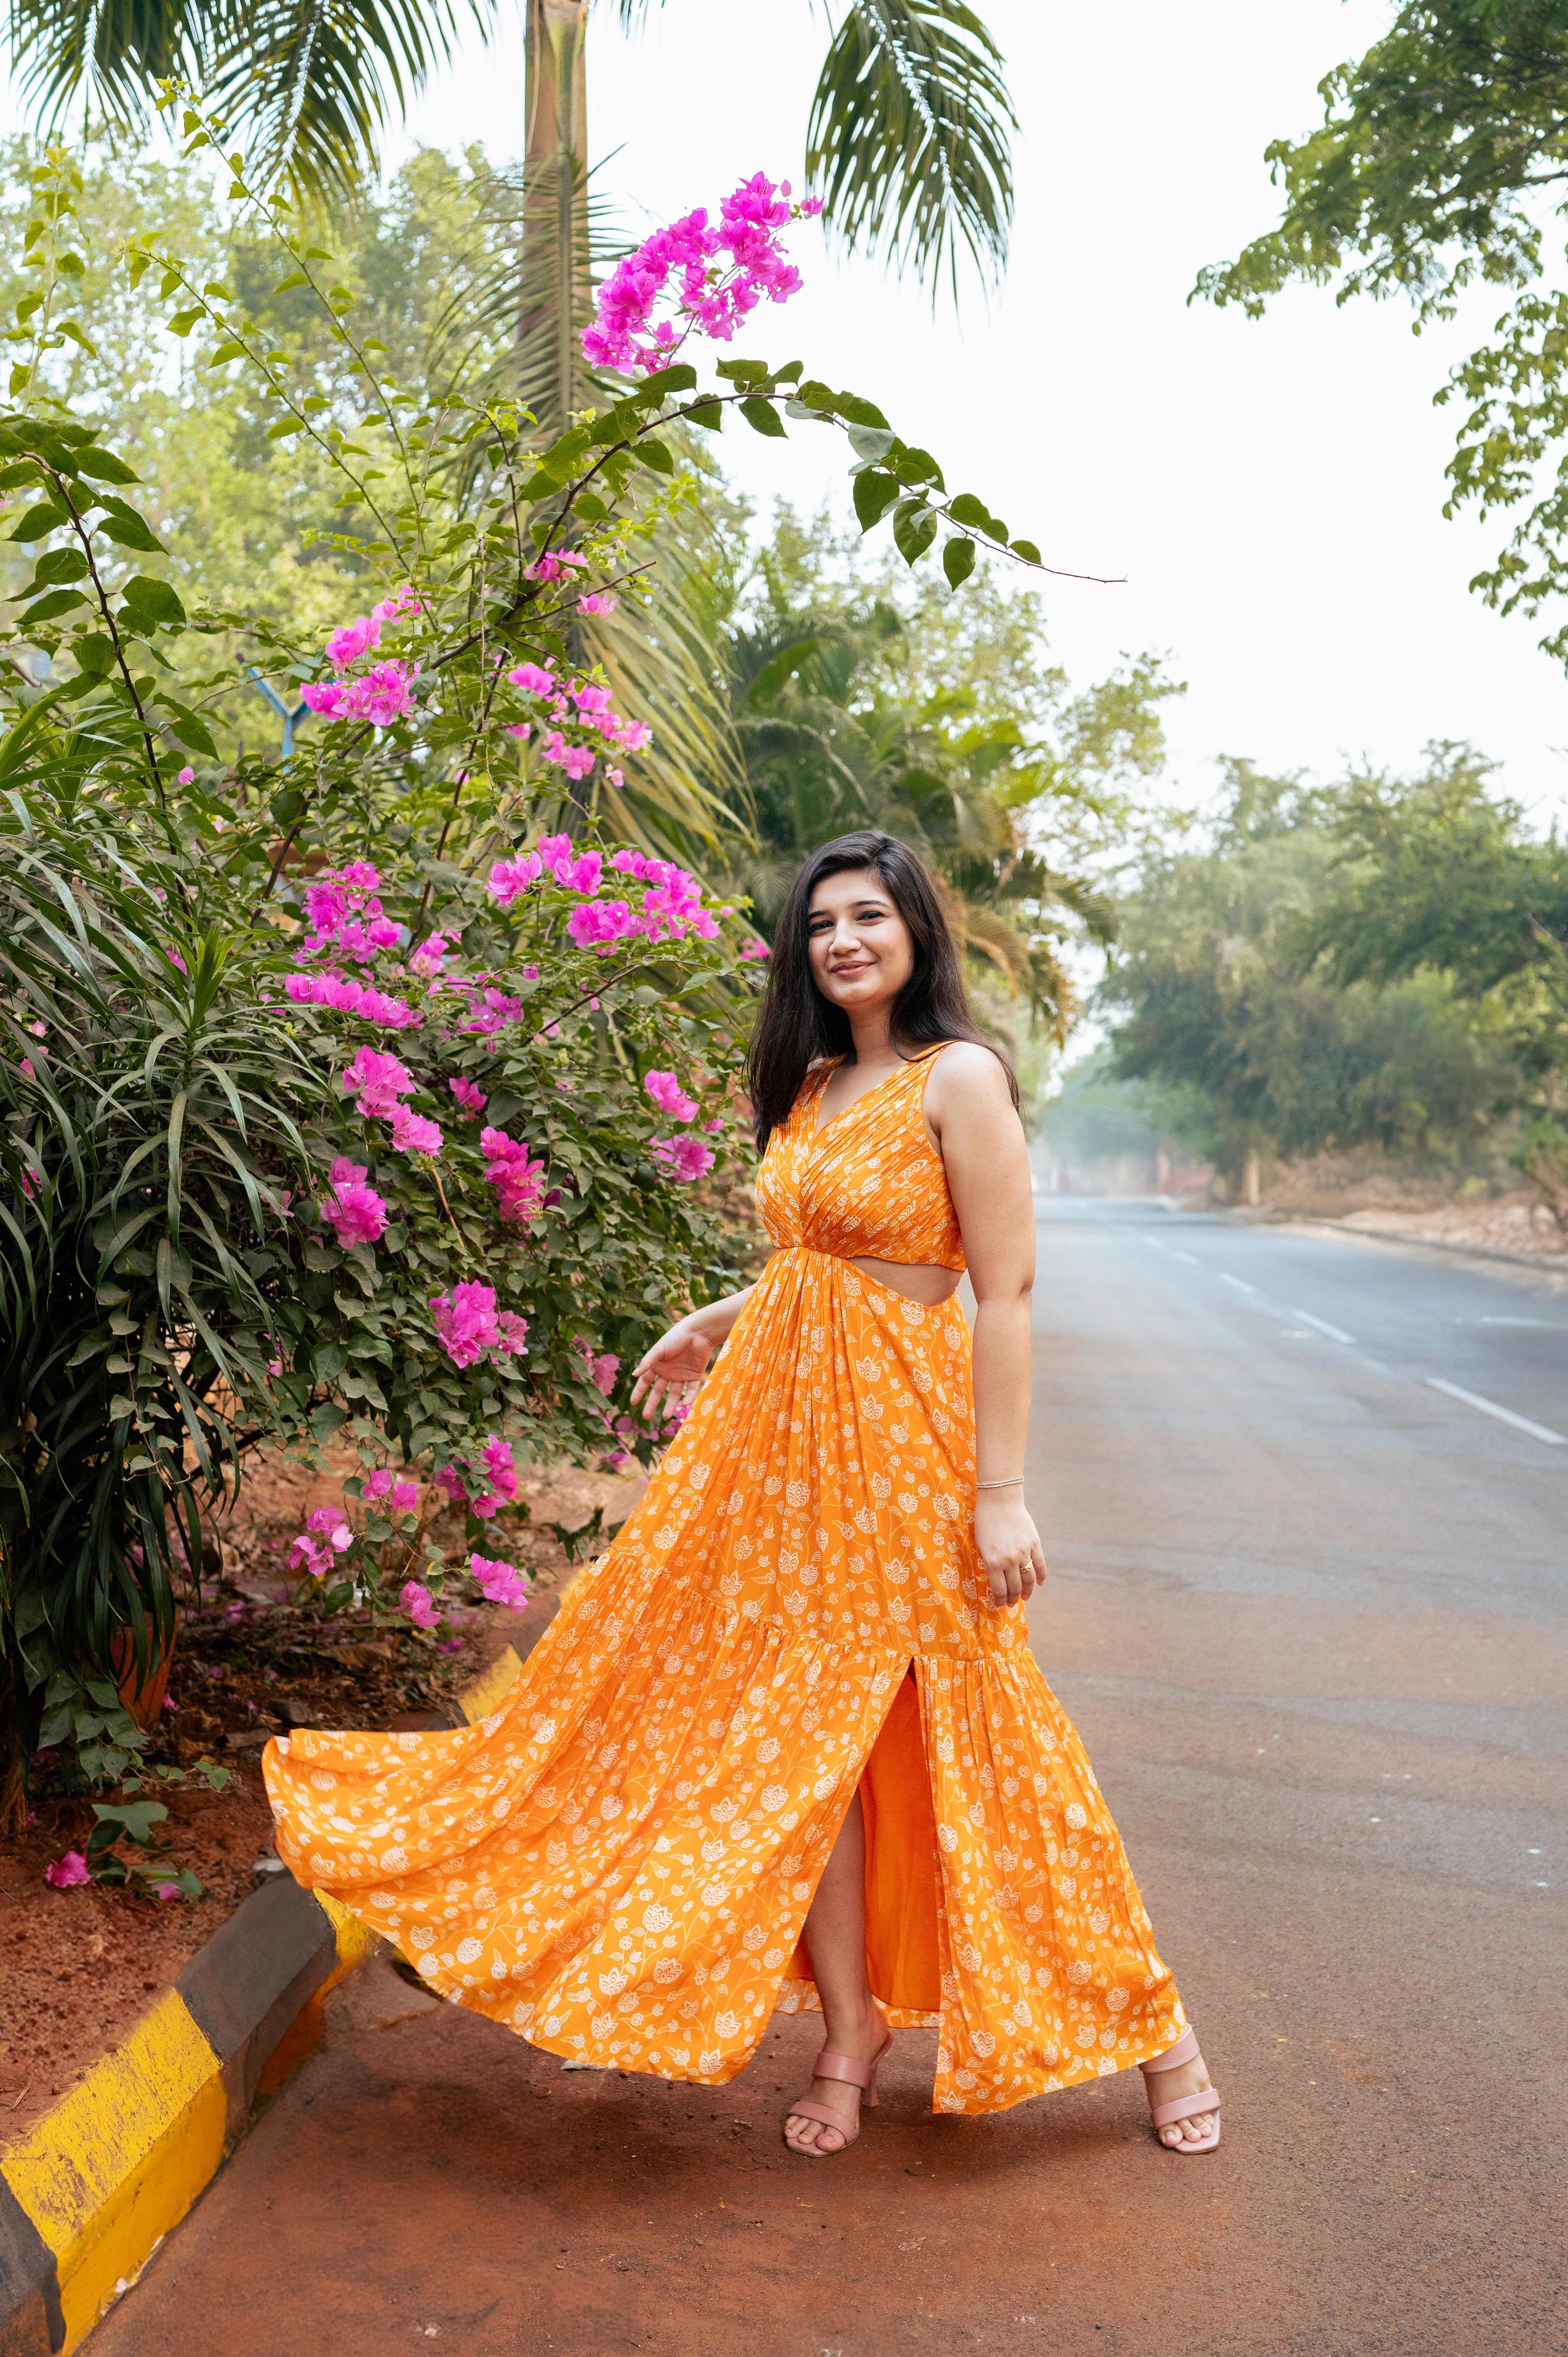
[757,1042,964,1268]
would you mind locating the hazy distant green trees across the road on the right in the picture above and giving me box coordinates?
[1080,745,1568,1225]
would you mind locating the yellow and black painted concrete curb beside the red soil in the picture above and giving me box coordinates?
[0,1640,537,2357]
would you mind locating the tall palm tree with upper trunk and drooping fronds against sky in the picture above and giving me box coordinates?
[12,0,1016,332]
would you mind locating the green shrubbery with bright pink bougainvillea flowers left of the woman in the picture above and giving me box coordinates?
[0,108,1038,1810]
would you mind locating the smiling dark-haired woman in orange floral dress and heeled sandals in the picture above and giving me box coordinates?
[266,835,1219,2159]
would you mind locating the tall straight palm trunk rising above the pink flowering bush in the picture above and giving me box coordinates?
[528,0,592,434]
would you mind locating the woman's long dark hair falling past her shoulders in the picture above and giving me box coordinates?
[747,827,1018,1153]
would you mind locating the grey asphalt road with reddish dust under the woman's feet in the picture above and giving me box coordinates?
[92,1202,1568,2357]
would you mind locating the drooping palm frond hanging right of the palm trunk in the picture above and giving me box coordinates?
[806,0,1018,292]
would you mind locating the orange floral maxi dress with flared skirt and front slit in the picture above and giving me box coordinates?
[264,1056,1186,2112]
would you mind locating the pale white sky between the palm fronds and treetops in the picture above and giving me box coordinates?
[5,0,1568,820]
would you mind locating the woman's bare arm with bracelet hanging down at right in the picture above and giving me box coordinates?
[924,1039,1044,1605]
